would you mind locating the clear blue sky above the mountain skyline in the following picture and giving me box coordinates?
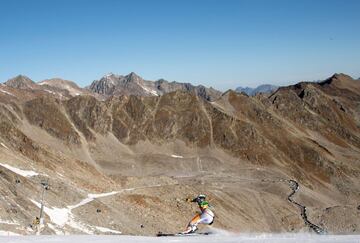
[0,0,360,90]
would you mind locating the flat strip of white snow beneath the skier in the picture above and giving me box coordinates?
[0,234,360,243]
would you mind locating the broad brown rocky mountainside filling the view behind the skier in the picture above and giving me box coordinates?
[0,74,360,235]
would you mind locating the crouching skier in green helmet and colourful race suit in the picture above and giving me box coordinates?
[182,194,215,234]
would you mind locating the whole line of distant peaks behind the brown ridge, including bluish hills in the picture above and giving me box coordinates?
[1,72,278,101]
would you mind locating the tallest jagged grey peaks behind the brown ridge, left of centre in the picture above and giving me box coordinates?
[88,72,221,101]
